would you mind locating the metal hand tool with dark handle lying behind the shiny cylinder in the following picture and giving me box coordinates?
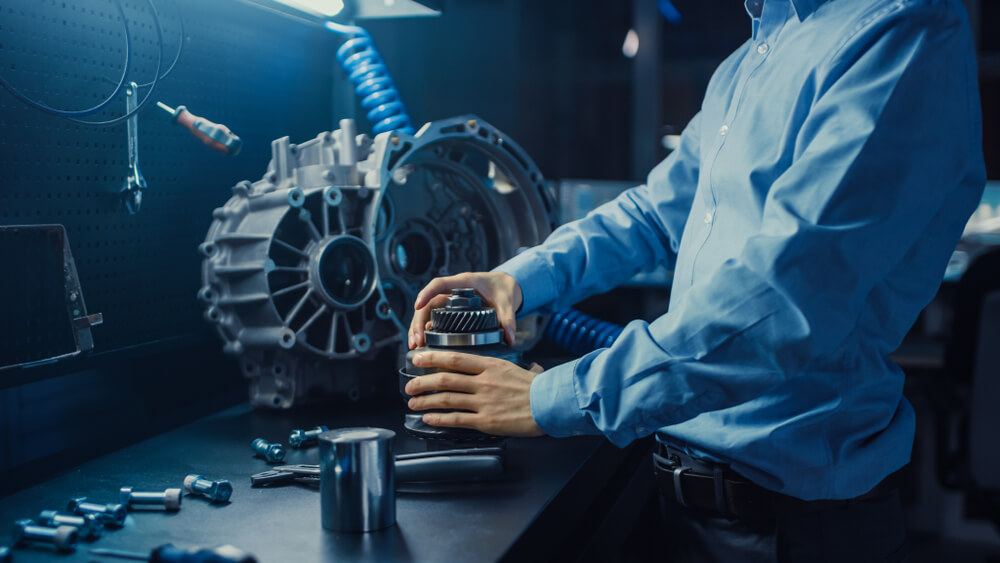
[250,447,504,487]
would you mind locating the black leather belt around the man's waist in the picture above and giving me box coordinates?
[653,444,892,520]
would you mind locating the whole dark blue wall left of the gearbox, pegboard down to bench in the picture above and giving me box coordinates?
[0,0,337,492]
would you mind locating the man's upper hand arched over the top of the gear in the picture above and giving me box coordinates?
[410,272,523,350]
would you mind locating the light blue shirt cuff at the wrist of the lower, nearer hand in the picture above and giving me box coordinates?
[531,361,601,438]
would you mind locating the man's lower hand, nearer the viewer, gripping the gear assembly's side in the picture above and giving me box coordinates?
[406,352,543,436]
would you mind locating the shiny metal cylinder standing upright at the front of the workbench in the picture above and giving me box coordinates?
[319,427,396,532]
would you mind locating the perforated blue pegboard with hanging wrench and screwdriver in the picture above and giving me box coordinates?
[0,0,339,368]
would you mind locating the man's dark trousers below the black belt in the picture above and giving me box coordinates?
[659,490,908,563]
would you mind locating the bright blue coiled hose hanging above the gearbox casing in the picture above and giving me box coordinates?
[326,22,417,135]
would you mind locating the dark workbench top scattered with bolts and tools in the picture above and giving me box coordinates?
[0,403,648,563]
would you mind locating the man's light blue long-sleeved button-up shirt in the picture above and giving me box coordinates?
[499,0,985,499]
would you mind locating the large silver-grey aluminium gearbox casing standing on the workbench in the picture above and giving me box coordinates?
[198,116,556,408]
